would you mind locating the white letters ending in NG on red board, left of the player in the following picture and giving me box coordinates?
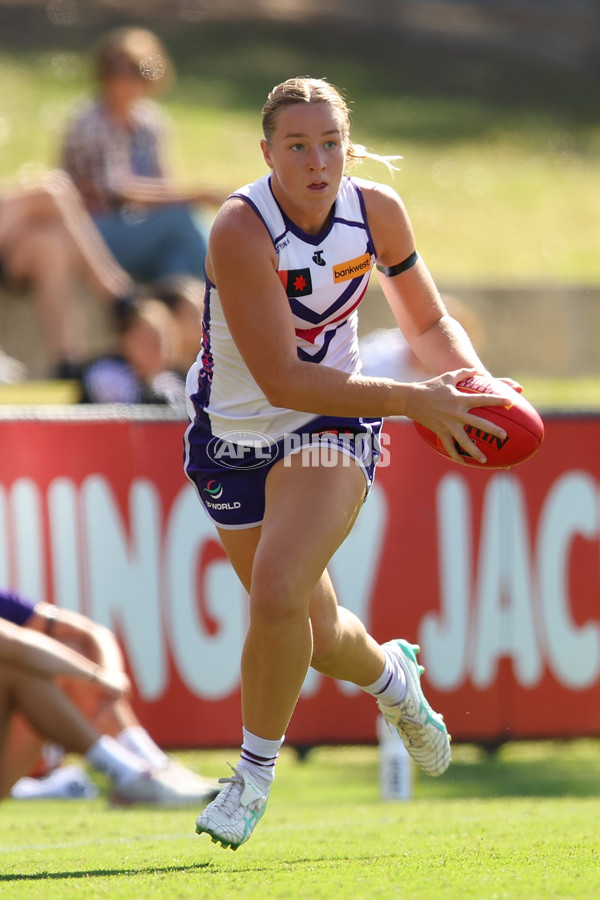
[0,475,246,701]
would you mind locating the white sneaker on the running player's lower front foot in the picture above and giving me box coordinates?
[196,766,269,850]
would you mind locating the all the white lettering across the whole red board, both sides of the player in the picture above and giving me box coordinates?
[0,470,600,701]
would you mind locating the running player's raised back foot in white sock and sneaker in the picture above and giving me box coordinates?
[377,640,451,776]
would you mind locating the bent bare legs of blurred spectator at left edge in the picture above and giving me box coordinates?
[0,172,136,377]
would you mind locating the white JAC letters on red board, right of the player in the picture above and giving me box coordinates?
[419,471,600,691]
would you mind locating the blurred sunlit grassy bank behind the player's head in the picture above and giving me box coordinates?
[0,11,600,284]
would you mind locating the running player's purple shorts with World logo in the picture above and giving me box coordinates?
[184,416,382,529]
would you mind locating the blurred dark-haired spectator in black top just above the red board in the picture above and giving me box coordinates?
[80,299,185,410]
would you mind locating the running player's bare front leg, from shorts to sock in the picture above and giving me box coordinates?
[242,451,372,740]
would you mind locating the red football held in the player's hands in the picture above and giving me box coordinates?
[414,375,544,469]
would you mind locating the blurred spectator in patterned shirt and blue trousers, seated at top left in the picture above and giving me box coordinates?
[62,28,224,283]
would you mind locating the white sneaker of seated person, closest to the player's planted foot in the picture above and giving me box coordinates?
[111,769,219,809]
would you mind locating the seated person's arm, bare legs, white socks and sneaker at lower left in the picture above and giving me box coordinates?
[0,591,218,806]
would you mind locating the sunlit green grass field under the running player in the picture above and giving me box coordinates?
[0,740,600,900]
